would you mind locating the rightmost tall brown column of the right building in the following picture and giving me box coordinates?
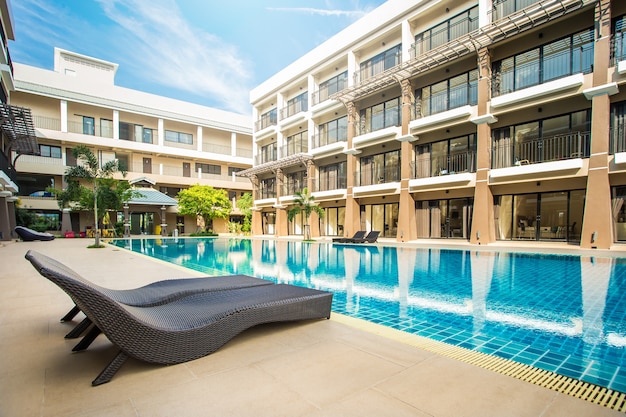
[580,0,614,249]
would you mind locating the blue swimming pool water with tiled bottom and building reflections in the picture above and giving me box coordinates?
[112,238,626,392]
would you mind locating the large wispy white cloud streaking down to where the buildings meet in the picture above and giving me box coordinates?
[98,0,251,114]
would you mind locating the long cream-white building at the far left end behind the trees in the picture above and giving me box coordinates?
[9,49,252,234]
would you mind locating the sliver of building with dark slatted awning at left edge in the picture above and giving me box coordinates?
[0,0,38,241]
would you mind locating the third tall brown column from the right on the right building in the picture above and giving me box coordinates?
[396,80,417,242]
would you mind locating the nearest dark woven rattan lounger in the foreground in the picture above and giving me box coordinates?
[26,250,332,385]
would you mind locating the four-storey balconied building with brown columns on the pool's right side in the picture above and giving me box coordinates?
[242,0,626,248]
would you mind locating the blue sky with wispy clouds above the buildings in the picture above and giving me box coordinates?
[9,0,384,114]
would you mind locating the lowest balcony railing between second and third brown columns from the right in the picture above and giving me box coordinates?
[411,151,476,178]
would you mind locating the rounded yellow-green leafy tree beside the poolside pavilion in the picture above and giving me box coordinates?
[178,184,232,231]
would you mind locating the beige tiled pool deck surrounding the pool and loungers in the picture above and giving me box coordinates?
[0,239,626,417]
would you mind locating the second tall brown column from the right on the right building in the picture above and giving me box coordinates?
[470,48,496,245]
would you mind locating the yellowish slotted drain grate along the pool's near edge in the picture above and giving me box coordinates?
[330,312,626,412]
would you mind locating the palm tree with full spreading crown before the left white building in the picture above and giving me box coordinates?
[51,145,133,247]
